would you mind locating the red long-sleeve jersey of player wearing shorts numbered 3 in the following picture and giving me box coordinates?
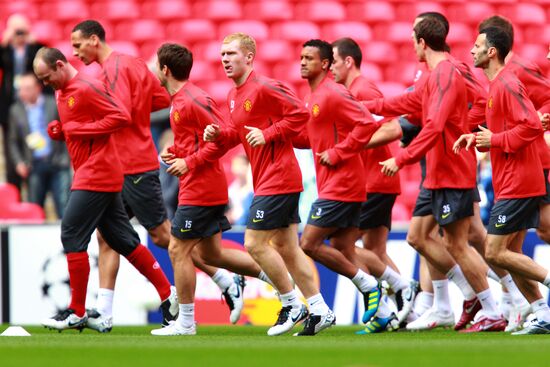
[301,77,380,202]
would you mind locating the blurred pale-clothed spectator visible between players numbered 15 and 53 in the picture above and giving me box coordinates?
[227,154,254,226]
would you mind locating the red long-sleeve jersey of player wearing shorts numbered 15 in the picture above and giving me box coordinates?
[170,81,228,206]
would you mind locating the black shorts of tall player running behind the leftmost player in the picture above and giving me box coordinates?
[122,169,168,230]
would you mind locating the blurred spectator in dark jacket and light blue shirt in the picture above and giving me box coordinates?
[6,73,71,218]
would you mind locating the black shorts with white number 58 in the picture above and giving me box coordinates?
[487,196,541,235]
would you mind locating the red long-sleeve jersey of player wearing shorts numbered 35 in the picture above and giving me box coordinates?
[366,60,476,190]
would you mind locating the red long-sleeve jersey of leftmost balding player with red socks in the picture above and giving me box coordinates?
[56,74,130,192]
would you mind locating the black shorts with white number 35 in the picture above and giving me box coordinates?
[429,189,474,227]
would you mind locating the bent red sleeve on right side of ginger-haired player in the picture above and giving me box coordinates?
[256,82,309,144]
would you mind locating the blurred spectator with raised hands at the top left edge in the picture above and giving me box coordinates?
[0,14,46,190]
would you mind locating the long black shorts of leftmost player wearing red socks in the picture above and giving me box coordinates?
[61,190,139,256]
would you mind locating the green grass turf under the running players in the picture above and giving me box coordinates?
[0,325,550,367]
